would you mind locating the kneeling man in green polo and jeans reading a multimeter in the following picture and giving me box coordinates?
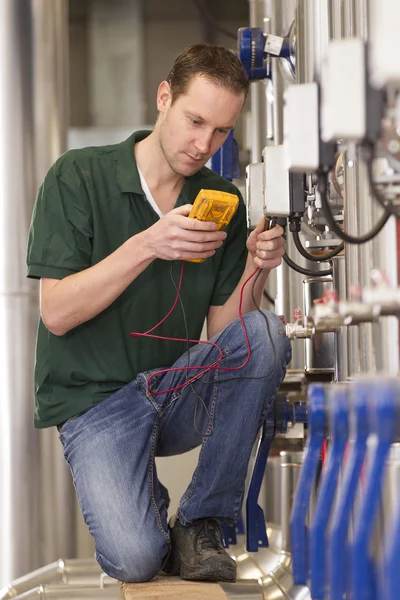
[27,45,290,582]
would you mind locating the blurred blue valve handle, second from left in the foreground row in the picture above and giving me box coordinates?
[310,385,349,600]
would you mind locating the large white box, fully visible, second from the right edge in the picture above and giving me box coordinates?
[321,38,367,142]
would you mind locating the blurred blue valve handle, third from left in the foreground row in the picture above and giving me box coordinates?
[327,384,369,600]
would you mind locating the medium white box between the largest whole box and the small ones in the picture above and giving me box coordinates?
[284,83,319,173]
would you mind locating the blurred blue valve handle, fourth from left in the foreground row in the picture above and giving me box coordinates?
[350,380,399,600]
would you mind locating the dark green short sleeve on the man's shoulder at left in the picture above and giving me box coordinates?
[27,153,93,279]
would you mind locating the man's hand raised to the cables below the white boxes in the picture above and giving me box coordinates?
[247,217,285,270]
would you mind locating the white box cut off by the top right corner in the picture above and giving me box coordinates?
[369,0,400,89]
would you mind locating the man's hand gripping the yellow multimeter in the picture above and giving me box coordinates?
[143,204,226,260]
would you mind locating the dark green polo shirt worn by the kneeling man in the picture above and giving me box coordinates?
[27,131,247,428]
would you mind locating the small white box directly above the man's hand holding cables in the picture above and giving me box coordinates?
[262,145,290,217]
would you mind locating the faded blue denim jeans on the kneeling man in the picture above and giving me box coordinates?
[60,311,291,582]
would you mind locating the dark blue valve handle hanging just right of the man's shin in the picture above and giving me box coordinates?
[246,420,274,552]
